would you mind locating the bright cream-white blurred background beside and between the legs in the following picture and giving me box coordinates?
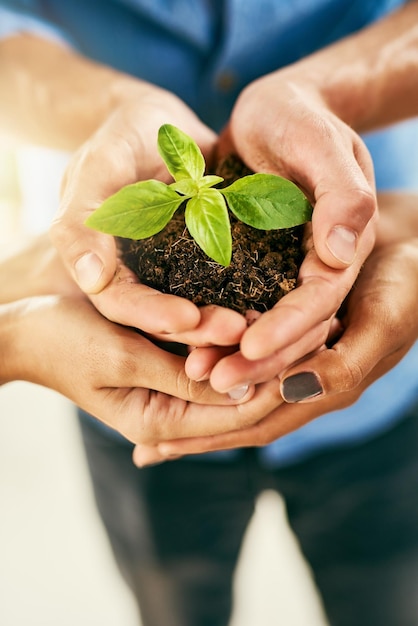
[0,143,326,626]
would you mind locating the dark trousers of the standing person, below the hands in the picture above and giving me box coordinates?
[77,405,418,626]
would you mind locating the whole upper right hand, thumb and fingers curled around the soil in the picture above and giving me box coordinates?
[212,63,377,368]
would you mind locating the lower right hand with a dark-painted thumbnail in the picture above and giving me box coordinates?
[134,195,418,465]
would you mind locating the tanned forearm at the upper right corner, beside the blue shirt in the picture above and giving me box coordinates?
[285,0,418,132]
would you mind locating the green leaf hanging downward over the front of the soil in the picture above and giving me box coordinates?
[185,189,232,267]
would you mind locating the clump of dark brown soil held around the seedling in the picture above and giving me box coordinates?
[118,157,304,314]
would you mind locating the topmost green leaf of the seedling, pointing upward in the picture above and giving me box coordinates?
[158,124,205,180]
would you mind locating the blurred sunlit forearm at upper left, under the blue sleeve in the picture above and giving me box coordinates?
[0,34,159,150]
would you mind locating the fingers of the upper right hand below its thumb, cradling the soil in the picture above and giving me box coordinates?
[186,221,372,392]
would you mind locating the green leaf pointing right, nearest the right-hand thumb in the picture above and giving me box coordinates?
[220,174,312,230]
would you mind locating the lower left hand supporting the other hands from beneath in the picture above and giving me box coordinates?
[0,236,279,443]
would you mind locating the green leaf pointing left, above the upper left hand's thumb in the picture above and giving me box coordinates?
[85,180,184,239]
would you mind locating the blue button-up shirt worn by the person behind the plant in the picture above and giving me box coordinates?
[0,0,418,466]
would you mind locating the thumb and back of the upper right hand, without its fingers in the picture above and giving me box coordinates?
[225,67,377,269]
